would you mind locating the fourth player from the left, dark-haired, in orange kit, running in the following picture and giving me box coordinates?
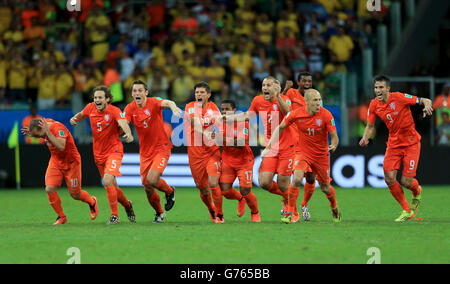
[184,82,245,223]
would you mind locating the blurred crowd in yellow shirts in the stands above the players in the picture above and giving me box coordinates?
[0,0,391,109]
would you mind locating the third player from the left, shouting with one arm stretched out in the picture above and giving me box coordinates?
[124,80,182,223]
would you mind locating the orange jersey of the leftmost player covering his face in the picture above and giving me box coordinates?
[44,118,81,169]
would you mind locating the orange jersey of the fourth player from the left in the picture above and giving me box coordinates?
[184,101,220,158]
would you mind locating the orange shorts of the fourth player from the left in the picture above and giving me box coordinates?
[189,152,222,189]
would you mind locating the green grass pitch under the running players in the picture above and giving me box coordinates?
[0,186,450,264]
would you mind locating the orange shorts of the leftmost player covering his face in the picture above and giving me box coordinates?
[45,162,81,194]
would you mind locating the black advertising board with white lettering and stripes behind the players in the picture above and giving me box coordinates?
[0,144,450,188]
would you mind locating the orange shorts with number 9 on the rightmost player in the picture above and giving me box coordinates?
[383,143,420,177]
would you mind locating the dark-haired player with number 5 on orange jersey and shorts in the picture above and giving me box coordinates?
[70,86,136,225]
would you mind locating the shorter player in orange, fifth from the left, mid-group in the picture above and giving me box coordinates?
[214,100,261,222]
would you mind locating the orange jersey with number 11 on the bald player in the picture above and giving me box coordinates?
[283,107,336,159]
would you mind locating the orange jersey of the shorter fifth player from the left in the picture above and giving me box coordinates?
[219,121,254,167]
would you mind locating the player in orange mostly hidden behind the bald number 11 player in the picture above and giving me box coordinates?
[280,72,316,222]
